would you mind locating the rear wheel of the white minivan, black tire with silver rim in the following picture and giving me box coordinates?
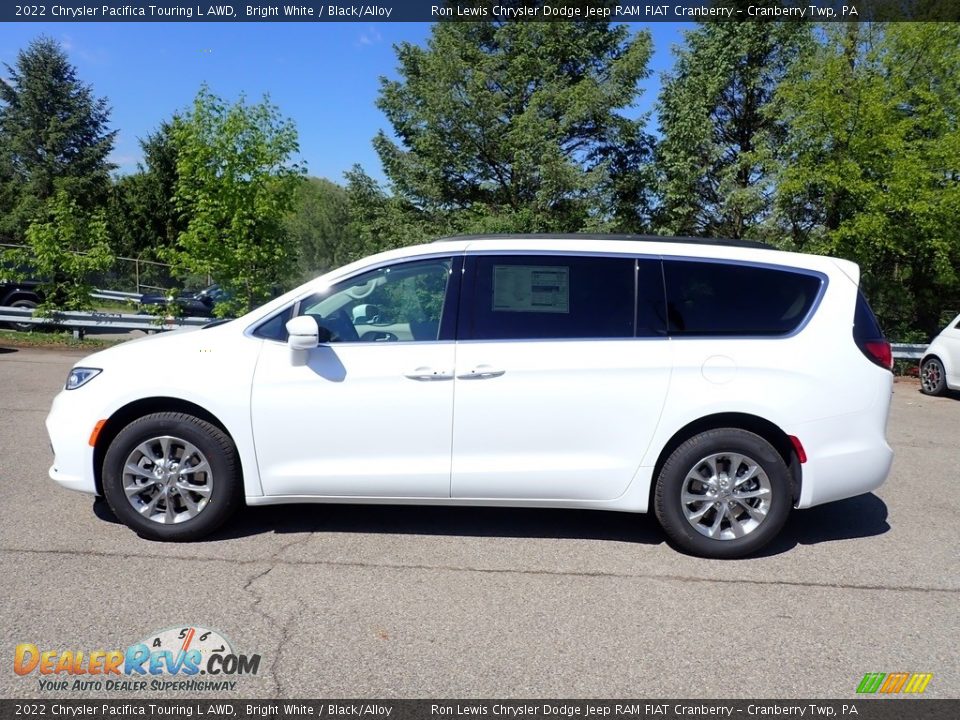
[654,428,793,559]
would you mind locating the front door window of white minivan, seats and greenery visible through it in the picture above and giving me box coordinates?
[297,258,451,343]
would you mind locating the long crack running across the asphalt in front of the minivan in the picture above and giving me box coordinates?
[0,539,960,592]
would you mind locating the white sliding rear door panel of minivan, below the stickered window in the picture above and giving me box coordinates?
[451,339,670,500]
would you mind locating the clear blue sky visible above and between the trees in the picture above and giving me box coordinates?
[0,22,690,182]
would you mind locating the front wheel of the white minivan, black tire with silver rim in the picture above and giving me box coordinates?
[103,412,243,542]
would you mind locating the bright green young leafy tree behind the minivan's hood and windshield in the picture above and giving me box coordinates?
[168,87,304,315]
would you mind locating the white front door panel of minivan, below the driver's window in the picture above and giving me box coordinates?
[251,341,454,497]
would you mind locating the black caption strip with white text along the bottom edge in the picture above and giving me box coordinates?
[0,697,960,720]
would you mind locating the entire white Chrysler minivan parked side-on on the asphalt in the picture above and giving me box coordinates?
[47,235,893,558]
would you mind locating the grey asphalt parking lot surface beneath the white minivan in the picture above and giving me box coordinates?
[0,348,960,698]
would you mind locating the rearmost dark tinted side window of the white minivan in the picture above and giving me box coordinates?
[663,260,823,336]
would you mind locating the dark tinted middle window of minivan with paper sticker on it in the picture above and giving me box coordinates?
[460,255,635,340]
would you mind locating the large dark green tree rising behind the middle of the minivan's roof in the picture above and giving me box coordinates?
[374,21,651,231]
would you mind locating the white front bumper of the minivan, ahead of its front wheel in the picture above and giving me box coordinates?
[46,388,100,494]
